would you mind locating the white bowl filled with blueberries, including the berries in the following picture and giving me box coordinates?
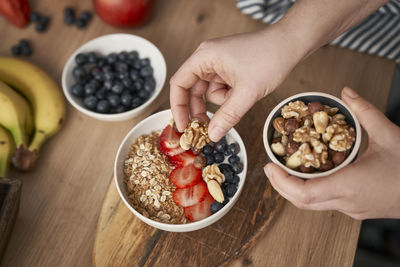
[62,34,167,121]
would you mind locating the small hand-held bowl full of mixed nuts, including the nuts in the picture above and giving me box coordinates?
[263,92,361,179]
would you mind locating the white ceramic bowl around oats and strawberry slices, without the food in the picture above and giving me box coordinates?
[114,109,247,232]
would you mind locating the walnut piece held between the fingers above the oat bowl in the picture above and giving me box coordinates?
[179,119,210,150]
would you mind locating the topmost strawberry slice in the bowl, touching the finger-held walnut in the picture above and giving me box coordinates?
[158,125,185,156]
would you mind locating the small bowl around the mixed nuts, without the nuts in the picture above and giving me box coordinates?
[263,92,361,179]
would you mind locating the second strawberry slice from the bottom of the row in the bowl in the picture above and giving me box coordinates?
[172,181,208,207]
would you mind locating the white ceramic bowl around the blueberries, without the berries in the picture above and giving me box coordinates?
[61,33,167,121]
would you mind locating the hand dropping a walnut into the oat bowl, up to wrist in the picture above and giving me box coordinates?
[170,25,305,141]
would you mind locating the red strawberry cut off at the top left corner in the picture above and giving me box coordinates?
[0,0,30,28]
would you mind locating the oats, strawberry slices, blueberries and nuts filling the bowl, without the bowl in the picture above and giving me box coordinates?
[124,119,244,224]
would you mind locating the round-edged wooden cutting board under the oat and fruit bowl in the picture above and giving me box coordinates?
[93,99,284,266]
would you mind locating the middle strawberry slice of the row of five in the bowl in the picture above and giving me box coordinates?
[169,164,201,188]
